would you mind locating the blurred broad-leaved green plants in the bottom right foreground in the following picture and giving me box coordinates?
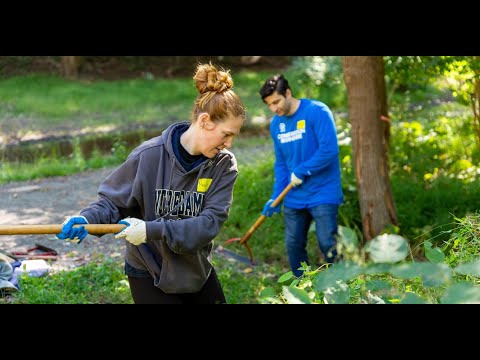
[261,219,480,304]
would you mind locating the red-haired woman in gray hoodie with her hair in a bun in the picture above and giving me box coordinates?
[57,63,246,304]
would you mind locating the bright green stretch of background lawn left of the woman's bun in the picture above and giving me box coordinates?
[0,75,196,124]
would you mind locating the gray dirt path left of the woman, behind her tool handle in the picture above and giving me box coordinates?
[0,168,124,271]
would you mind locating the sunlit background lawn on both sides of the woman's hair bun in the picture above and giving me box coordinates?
[0,72,278,137]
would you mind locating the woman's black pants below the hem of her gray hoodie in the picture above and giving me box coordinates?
[128,269,227,304]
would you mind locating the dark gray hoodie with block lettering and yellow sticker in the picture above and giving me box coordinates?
[80,122,238,293]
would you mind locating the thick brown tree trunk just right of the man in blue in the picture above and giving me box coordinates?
[342,56,398,242]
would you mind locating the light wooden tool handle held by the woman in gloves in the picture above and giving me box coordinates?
[0,224,125,235]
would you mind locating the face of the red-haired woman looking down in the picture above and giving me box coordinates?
[199,116,244,158]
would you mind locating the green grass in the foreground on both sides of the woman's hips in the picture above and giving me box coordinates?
[0,249,283,304]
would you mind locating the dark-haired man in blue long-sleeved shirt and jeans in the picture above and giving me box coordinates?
[260,75,343,277]
